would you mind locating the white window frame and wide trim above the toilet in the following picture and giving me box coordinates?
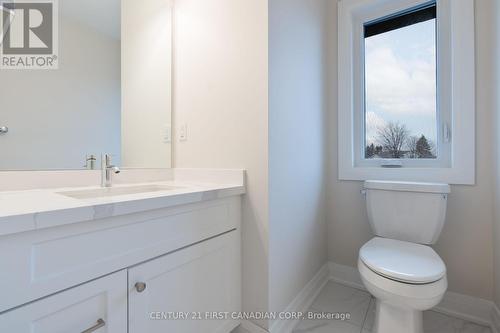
[338,0,475,185]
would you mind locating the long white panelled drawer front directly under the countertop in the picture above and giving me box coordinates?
[0,197,241,312]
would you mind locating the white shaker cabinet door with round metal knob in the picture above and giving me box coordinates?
[129,230,241,333]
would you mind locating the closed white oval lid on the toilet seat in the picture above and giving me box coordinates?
[359,237,446,284]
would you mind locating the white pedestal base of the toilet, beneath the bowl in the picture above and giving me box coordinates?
[373,299,424,333]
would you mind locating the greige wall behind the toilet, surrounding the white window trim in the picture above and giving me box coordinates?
[327,0,494,299]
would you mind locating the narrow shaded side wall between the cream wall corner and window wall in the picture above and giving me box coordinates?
[269,0,328,311]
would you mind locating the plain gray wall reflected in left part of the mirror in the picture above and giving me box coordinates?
[0,16,120,170]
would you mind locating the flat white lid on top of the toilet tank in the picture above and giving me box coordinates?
[364,180,450,194]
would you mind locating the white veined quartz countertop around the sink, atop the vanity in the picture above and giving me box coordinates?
[0,175,245,236]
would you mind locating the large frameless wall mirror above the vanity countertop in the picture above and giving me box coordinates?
[0,0,173,170]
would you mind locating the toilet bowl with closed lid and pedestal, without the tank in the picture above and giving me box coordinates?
[358,238,448,333]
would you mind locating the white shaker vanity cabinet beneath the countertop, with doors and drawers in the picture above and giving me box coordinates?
[0,196,241,333]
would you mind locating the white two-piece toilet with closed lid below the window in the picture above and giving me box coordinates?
[358,181,450,333]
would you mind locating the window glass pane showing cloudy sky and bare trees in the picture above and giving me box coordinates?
[365,19,438,159]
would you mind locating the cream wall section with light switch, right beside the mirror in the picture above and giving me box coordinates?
[173,0,269,327]
